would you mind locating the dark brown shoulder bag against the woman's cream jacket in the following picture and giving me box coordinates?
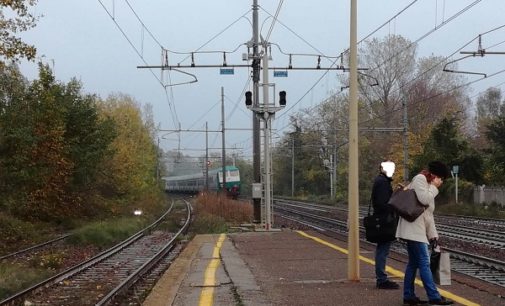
[388,188,428,222]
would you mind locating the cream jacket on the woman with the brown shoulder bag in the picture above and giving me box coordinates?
[396,174,438,243]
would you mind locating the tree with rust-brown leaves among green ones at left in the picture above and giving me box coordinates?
[8,65,76,220]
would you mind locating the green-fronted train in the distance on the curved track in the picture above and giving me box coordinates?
[163,166,240,198]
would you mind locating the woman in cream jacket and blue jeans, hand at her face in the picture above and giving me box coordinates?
[396,161,453,305]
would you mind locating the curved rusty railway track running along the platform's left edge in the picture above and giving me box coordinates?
[0,201,191,305]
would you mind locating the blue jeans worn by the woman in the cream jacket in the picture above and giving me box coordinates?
[403,240,441,300]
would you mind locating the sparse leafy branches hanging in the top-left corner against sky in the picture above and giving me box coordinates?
[0,0,37,65]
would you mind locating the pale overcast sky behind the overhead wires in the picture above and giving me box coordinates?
[17,0,505,158]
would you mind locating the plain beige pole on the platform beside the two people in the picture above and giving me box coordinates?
[347,0,360,281]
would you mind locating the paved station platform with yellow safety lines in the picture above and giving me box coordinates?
[143,230,505,306]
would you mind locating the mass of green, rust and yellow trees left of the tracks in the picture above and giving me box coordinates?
[0,65,161,223]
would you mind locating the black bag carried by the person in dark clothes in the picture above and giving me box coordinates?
[363,201,398,243]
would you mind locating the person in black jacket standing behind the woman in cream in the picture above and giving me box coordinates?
[372,160,400,289]
